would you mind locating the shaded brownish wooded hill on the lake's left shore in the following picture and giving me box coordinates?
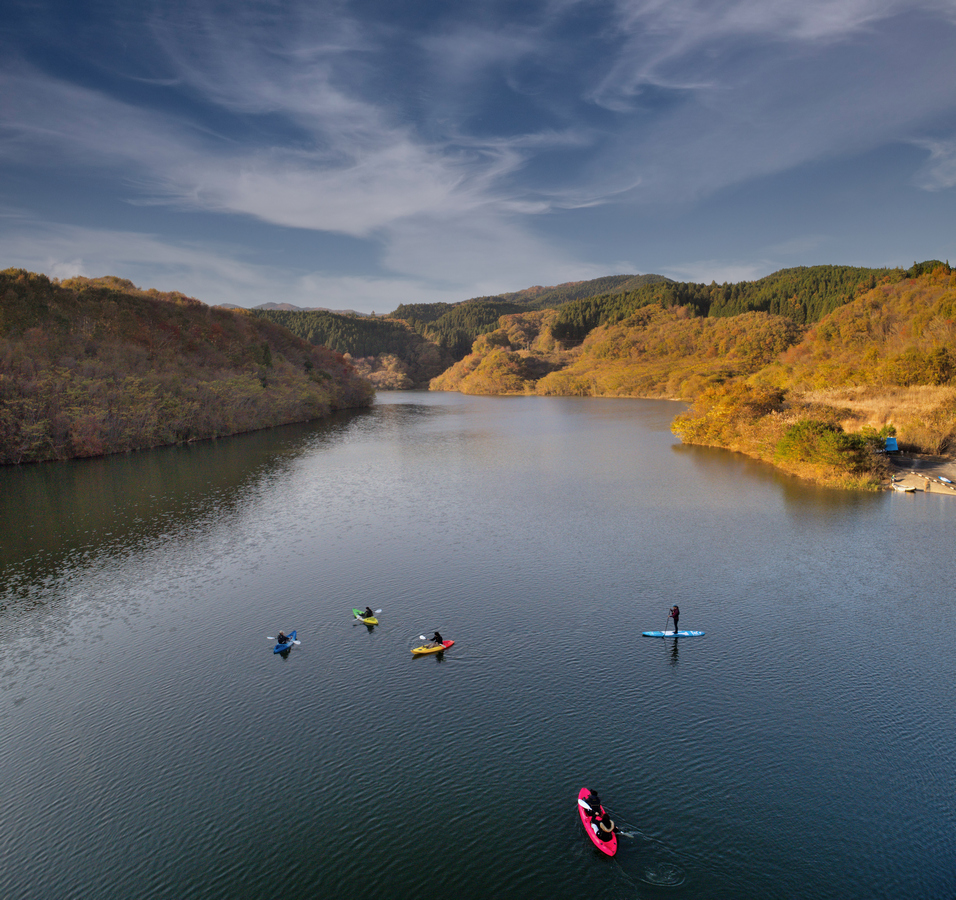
[0,269,372,463]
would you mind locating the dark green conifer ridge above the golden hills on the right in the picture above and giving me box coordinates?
[554,261,912,341]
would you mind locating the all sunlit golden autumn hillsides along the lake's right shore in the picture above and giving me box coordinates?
[432,261,956,487]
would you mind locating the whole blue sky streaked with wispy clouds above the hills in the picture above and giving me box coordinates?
[0,0,956,313]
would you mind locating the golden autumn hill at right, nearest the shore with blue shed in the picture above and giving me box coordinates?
[674,264,956,486]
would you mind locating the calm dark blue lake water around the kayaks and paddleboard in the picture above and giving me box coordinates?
[0,393,956,900]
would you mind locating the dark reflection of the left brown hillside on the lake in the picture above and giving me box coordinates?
[0,410,369,607]
